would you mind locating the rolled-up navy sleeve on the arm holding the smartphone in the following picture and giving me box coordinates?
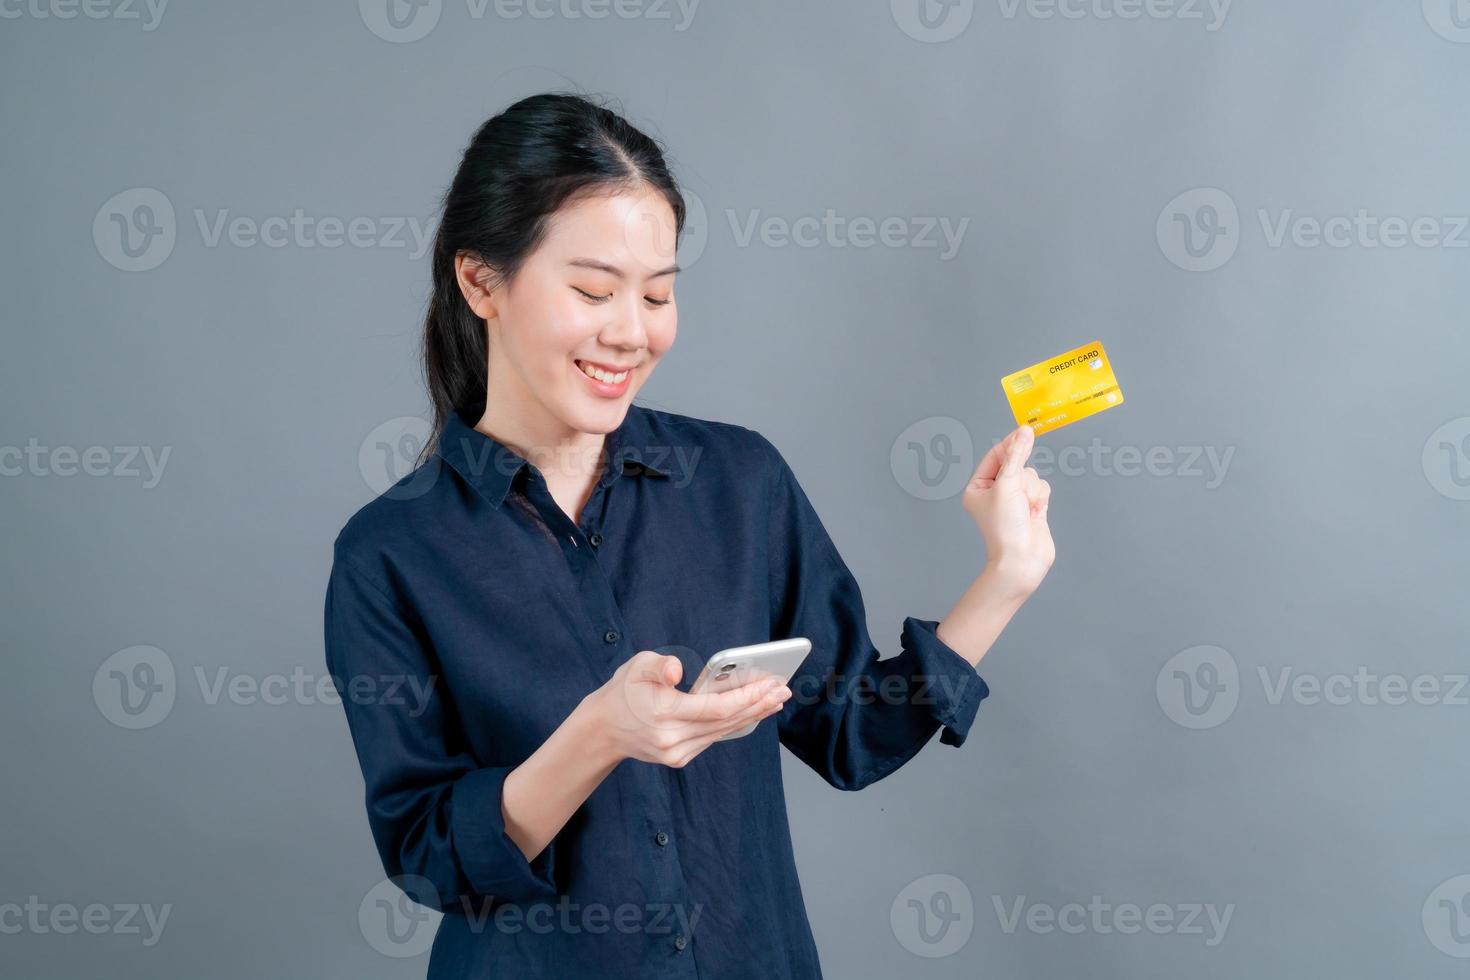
[323,551,557,911]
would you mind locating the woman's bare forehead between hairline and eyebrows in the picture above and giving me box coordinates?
[541,184,676,270]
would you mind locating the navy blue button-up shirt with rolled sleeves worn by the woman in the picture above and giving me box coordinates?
[325,404,988,980]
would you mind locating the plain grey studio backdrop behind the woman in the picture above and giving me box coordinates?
[0,0,1470,980]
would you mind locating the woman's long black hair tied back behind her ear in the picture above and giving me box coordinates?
[423,93,685,458]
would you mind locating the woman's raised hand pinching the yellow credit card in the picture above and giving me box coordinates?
[964,425,1057,595]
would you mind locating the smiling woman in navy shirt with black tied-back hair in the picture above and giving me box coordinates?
[325,94,1054,980]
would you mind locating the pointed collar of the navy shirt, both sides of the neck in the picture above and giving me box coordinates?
[435,404,673,508]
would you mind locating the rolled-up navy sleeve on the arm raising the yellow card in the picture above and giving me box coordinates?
[757,433,989,789]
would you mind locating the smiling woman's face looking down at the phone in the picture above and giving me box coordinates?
[470,185,678,432]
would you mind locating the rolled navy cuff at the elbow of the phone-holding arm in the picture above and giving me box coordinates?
[450,767,557,902]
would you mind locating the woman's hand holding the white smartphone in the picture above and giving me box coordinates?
[588,649,791,768]
